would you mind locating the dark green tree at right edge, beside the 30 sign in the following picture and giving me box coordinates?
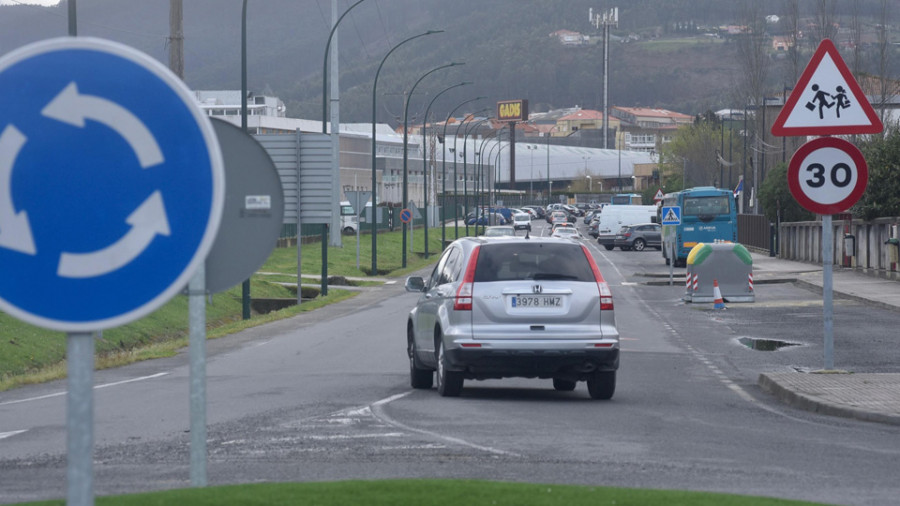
[854,124,900,220]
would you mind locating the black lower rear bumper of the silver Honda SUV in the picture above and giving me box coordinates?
[445,341,619,380]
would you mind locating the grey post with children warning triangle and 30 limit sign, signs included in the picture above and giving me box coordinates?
[772,39,884,370]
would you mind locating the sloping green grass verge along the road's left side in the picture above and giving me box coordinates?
[0,229,441,391]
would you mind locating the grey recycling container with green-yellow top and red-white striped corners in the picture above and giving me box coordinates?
[684,242,755,302]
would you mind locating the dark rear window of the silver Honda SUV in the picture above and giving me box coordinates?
[475,242,594,282]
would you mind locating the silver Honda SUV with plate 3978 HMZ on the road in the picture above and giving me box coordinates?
[406,236,619,399]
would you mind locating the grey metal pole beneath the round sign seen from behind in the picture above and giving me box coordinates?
[188,264,207,487]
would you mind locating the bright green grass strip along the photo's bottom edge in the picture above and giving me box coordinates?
[17,480,817,506]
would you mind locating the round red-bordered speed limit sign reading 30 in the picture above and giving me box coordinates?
[788,137,869,214]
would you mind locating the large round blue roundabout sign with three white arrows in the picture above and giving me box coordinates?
[0,37,225,332]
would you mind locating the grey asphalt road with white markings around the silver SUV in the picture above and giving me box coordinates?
[0,221,900,505]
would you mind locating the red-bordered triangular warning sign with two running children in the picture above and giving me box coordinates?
[772,39,884,136]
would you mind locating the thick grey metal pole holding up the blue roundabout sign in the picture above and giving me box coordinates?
[66,332,94,506]
